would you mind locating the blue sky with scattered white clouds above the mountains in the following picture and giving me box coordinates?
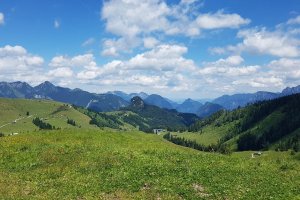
[0,0,300,99]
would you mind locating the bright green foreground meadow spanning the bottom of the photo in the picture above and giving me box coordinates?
[0,129,300,199]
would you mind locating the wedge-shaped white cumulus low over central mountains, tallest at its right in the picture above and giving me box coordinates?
[77,44,195,91]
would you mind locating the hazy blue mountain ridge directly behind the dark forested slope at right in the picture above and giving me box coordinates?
[212,91,280,110]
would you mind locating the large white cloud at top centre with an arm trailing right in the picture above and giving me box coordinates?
[101,0,250,56]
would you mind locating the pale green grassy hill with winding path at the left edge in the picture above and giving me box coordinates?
[0,98,91,134]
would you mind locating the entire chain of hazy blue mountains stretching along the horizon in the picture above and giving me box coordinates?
[0,81,300,117]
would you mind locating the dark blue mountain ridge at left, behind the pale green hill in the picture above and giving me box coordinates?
[0,81,129,112]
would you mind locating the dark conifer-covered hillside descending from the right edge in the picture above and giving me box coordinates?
[175,94,300,151]
